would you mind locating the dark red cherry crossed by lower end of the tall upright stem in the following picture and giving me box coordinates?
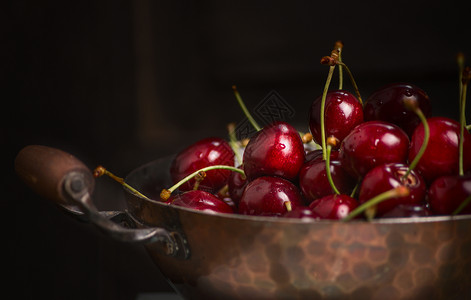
[299,151,356,202]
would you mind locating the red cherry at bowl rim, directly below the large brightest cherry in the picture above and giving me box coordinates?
[239,176,304,216]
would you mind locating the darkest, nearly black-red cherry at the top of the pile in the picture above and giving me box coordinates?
[363,83,432,137]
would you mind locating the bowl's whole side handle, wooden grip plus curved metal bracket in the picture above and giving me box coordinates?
[15,145,188,257]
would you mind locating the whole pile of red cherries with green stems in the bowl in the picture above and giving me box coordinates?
[155,48,471,220]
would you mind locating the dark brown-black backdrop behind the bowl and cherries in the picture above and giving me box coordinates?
[4,0,471,299]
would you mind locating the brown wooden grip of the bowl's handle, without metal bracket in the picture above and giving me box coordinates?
[15,145,95,205]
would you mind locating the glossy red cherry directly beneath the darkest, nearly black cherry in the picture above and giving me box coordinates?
[339,121,409,179]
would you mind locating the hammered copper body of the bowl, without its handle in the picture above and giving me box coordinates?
[127,157,471,300]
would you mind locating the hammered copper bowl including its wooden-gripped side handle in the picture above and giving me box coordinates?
[15,146,471,300]
